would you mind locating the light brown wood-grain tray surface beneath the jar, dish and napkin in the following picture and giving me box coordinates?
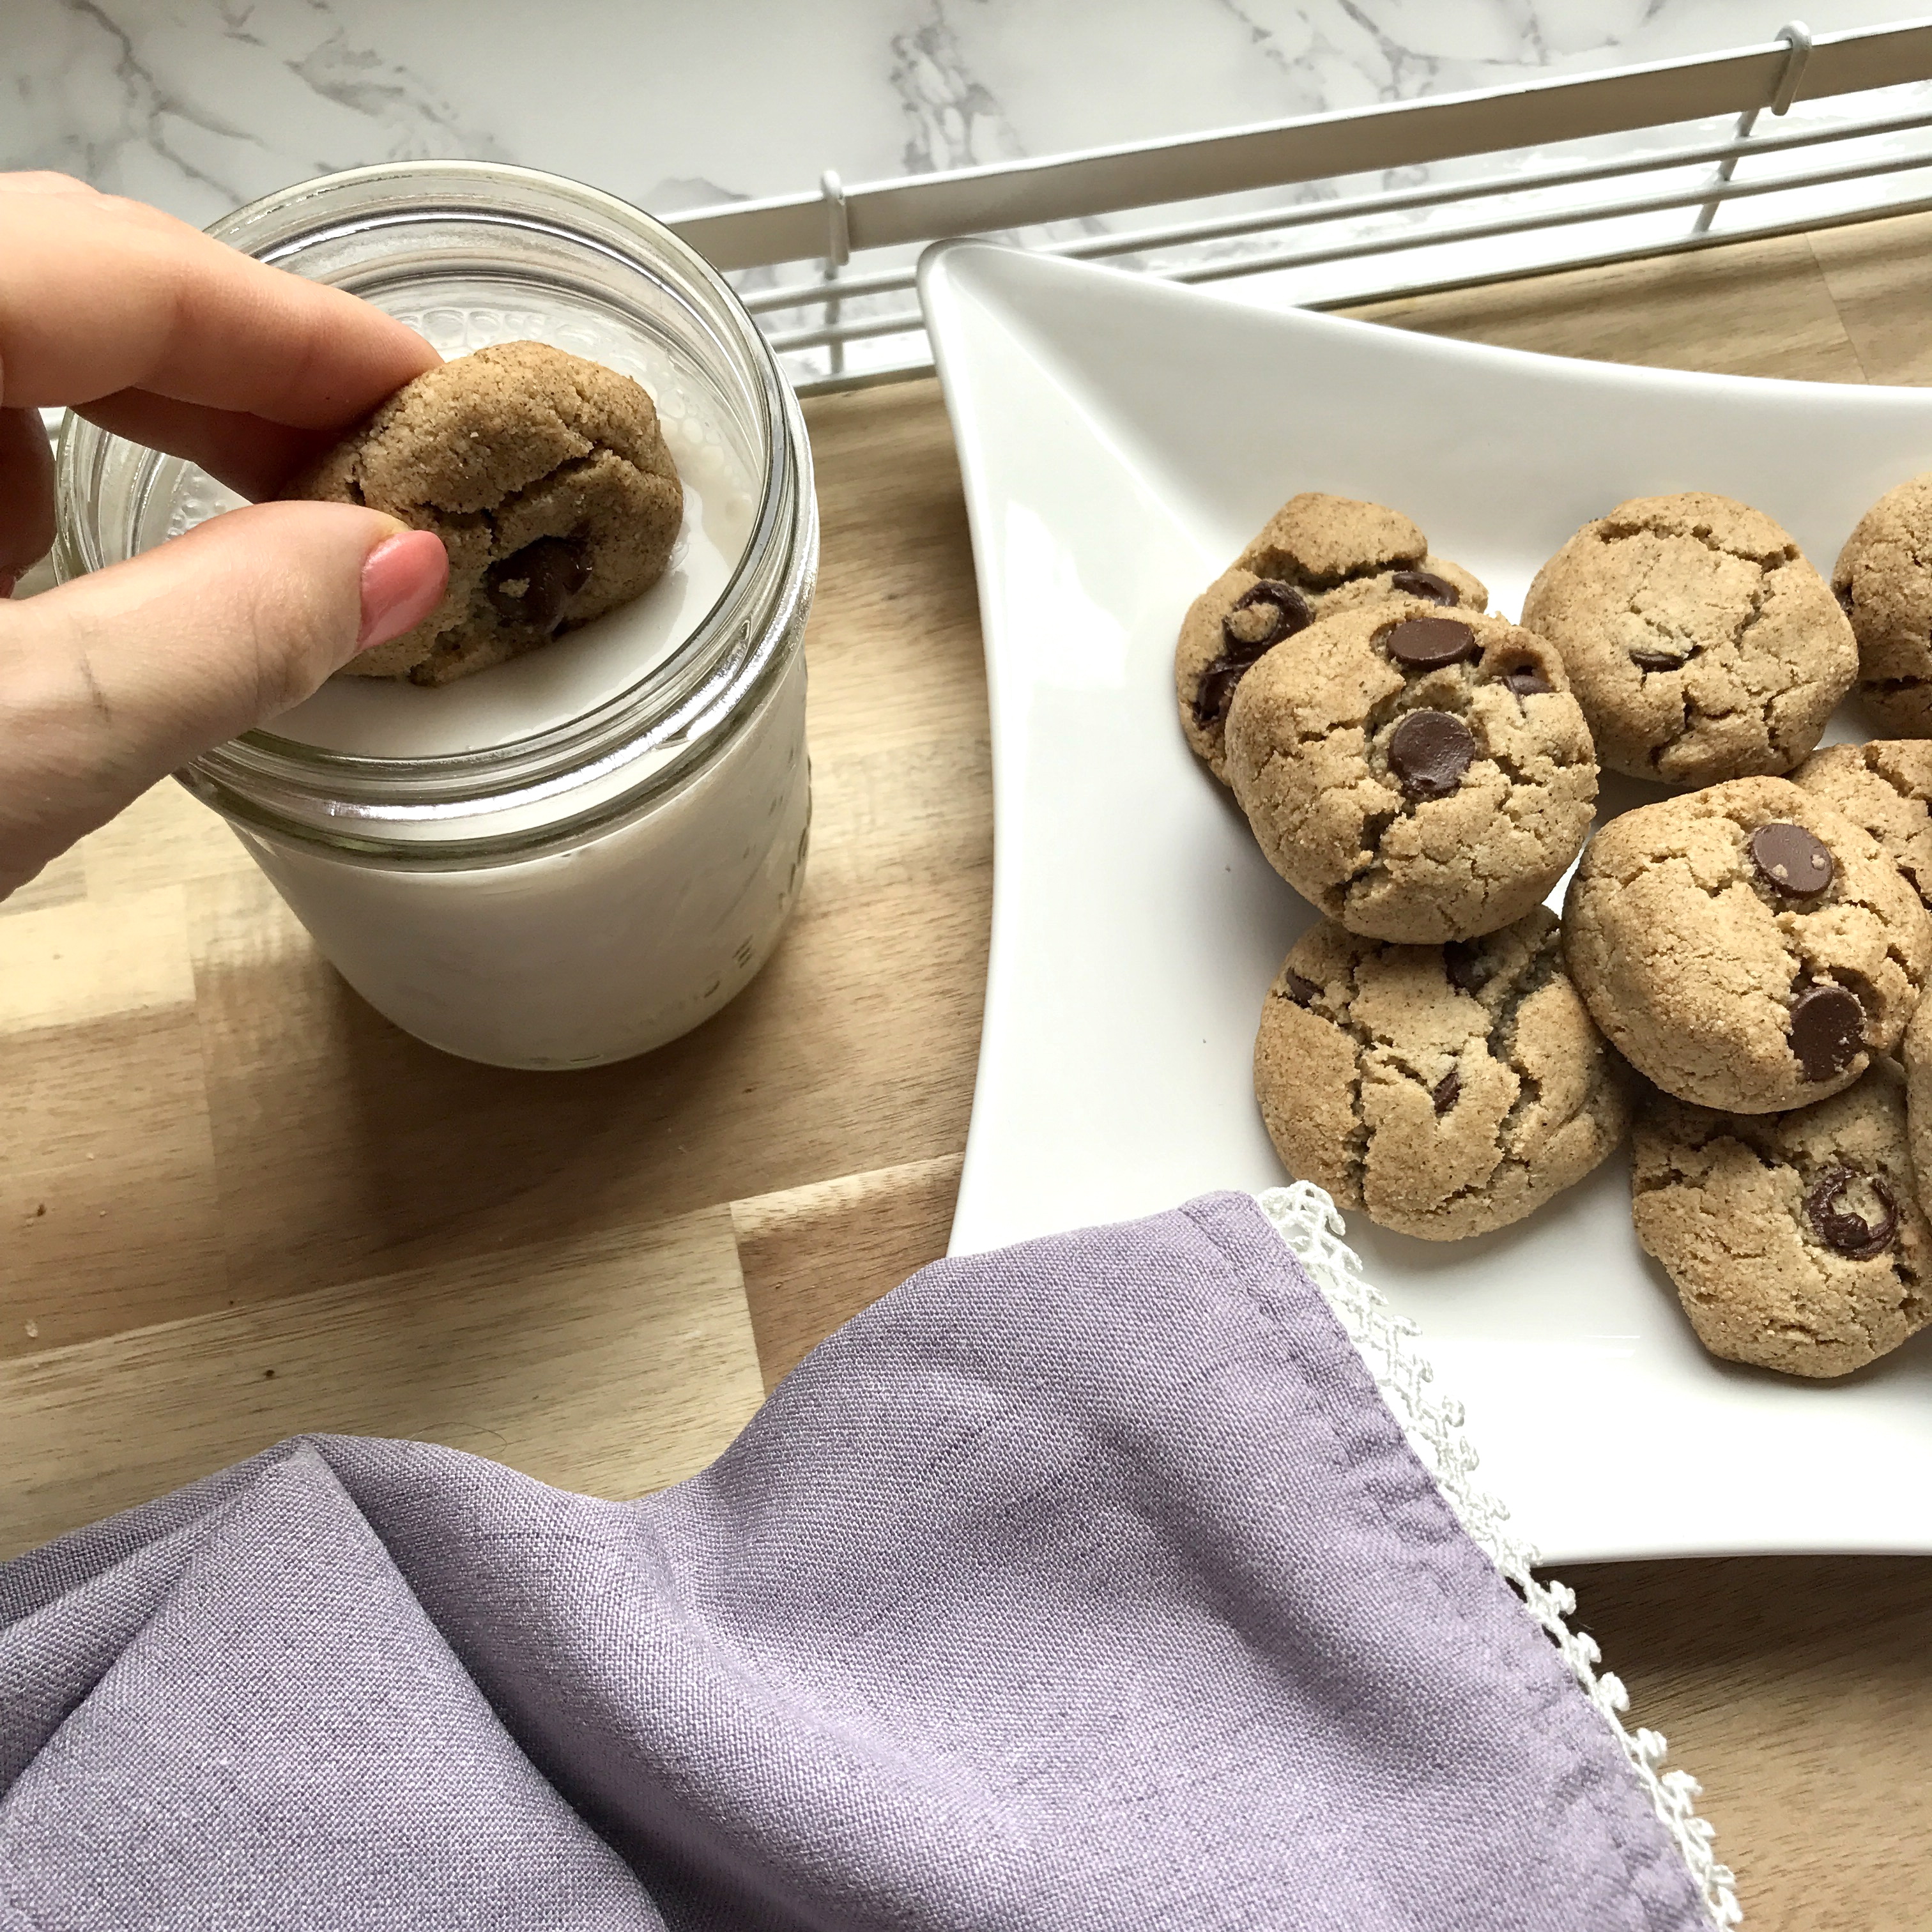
[11,217,1932,1932]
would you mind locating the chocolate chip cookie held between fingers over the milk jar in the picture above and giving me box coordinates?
[286,342,684,684]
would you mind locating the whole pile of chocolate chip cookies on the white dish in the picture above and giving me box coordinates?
[1175,477,1932,1376]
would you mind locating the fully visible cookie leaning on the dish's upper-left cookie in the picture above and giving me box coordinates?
[1227,597,1596,945]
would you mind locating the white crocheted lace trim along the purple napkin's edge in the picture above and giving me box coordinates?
[1258,1181,1745,1926]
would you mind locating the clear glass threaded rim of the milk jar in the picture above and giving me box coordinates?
[60,160,817,856]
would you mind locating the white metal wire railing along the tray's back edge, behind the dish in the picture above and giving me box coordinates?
[672,19,1932,390]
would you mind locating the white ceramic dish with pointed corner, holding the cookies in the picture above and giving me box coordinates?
[921,243,1932,1561]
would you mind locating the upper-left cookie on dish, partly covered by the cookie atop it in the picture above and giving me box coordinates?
[1175,491,1490,783]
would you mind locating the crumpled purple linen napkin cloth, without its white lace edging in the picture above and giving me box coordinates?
[0,1194,1712,1932]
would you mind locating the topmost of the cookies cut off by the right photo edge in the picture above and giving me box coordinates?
[1832,471,1932,738]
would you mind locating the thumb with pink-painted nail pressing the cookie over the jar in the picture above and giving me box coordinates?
[0,502,450,898]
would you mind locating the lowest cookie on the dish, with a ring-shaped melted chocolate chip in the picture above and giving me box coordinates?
[1630,1062,1932,1376]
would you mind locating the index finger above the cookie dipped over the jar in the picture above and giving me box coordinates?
[0,176,440,429]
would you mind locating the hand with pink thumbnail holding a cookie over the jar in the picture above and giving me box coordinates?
[0,174,448,898]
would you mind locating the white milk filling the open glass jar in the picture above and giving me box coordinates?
[166,309,815,1068]
